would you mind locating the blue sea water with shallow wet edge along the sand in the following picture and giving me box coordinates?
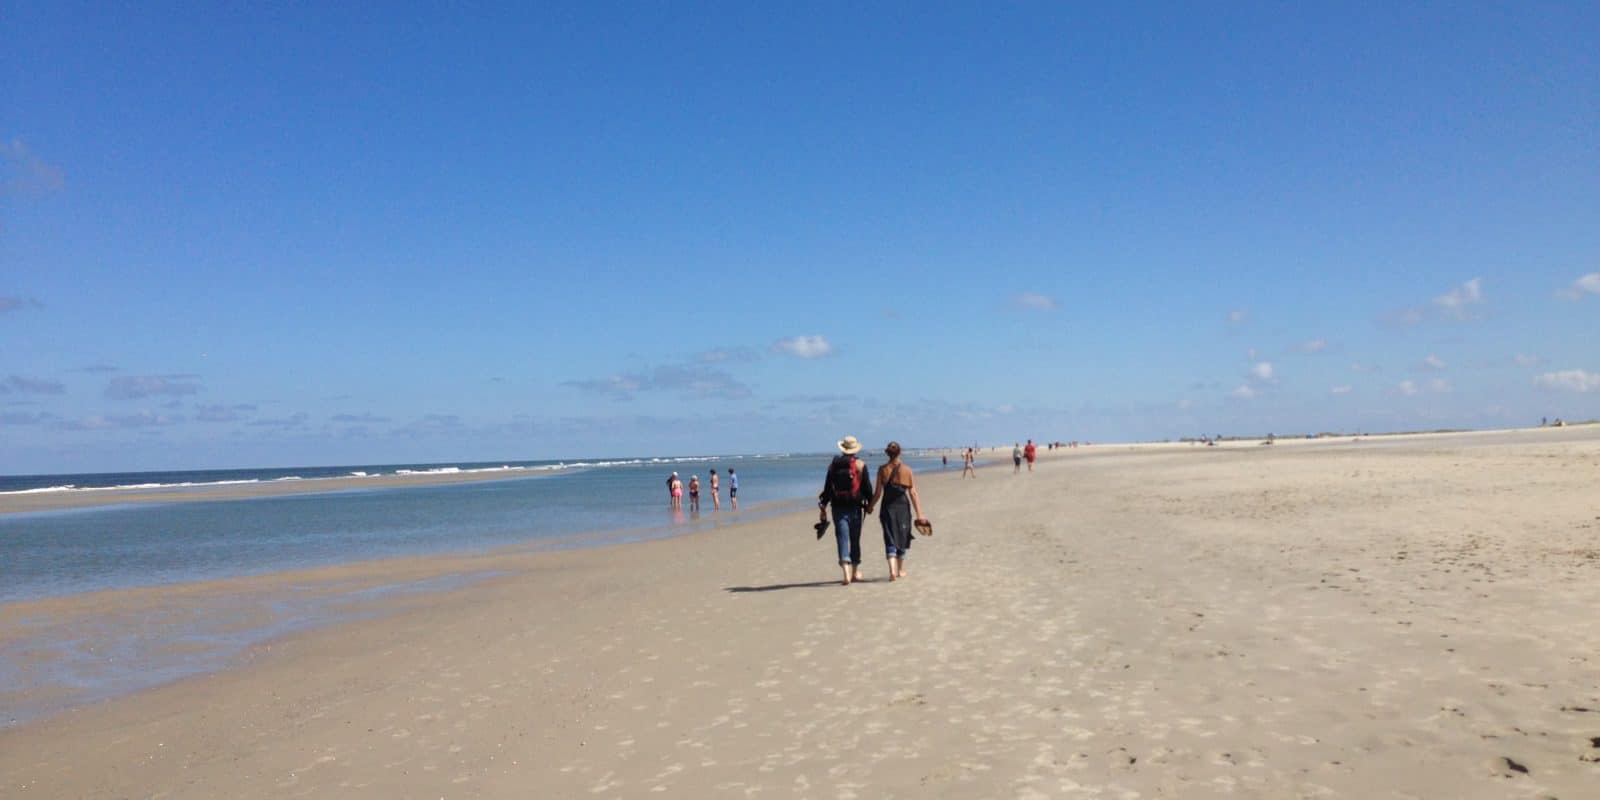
[0,454,939,725]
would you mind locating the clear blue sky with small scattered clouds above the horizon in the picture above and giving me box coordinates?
[0,3,1600,474]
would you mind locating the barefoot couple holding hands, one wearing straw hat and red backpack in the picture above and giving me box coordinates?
[816,437,933,586]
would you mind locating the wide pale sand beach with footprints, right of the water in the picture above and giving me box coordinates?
[0,426,1600,798]
